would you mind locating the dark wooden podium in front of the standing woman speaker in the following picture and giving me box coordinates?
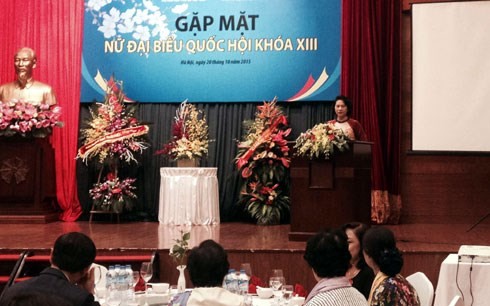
[289,142,372,241]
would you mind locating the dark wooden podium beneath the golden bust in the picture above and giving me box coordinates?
[0,136,59,223]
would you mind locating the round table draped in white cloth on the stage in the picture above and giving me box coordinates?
[158,167,220,225]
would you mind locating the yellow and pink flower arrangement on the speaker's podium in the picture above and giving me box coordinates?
[294,123,349,159]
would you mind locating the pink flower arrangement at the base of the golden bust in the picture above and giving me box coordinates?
[0,99,63,138]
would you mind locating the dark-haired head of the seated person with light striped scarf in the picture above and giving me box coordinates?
[304,229,351,278]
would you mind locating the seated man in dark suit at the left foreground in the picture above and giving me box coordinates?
[0,232,99,306]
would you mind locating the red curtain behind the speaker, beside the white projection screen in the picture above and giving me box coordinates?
[341,0,401,223]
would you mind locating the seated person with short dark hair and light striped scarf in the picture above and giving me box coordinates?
[304,229,367,306]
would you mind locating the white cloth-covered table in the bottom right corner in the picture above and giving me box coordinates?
[434,254,490,306]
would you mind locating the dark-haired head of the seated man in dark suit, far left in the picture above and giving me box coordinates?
[51,232,97,273]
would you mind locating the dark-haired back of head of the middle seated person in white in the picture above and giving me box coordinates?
[187,239,230,287]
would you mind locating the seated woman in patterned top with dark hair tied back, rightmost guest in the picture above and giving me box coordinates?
[362,227,420,306]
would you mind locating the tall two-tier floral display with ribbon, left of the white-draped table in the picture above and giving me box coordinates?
[77,78,149,213]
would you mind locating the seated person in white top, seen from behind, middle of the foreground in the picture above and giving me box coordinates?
[170,239,243,306]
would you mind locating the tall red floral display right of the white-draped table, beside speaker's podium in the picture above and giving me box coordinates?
[235,99,291,225]
